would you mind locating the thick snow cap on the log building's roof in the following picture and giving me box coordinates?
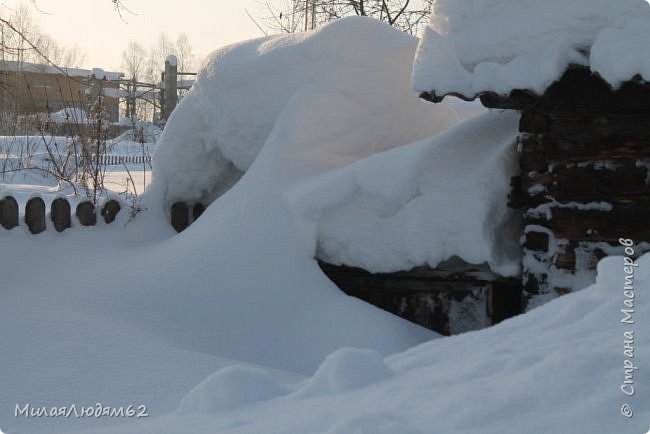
[413,0,650,101]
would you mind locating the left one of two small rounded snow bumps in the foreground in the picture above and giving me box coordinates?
[179,365,289,414]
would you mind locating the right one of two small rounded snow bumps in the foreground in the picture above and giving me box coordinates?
[293,348,394,398]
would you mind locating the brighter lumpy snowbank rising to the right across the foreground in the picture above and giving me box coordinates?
[73,255,650,434]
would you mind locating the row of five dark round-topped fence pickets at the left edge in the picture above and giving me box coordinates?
[0,196,122,234]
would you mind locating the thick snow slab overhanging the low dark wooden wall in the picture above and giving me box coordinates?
[289,112,520,276]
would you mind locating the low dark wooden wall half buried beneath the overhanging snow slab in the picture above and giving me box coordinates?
[319,259,522,336]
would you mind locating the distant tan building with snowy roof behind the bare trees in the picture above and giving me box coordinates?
[0,61,124,121]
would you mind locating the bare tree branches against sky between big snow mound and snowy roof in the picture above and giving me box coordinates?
[258,0,431,34]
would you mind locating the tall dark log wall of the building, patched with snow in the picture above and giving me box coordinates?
[492,68,650,304]
